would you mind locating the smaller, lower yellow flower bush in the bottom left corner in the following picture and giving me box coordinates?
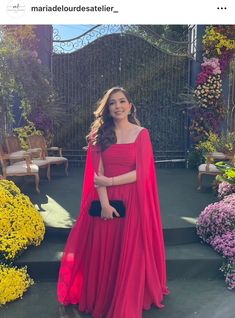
[0,264,34,306]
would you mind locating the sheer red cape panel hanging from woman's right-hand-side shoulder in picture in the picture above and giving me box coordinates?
[136,129,169,309]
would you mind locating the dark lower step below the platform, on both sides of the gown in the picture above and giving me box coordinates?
[15,238,222,281]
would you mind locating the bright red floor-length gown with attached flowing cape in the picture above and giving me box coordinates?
[58,128,169,318]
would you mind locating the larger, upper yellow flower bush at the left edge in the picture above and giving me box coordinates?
[0,180,45,260]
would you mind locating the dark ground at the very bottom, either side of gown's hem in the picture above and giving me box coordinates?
[0,279,235,318]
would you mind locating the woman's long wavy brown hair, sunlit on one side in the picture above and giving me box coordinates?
[87,86,140,151]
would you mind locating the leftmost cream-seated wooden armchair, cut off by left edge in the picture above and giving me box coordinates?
[0,146,40,193]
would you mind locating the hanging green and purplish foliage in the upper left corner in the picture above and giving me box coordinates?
[0,25,63,139]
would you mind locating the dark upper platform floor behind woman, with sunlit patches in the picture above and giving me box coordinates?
[20,166,217,244]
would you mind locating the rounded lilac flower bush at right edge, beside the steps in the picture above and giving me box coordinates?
[196,200,235,244]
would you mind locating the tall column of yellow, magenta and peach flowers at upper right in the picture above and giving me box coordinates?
[190,25,235,141]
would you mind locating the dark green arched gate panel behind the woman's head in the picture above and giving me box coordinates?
[52,25,190,160]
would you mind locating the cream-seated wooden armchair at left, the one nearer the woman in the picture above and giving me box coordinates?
[28,135,68,175]
